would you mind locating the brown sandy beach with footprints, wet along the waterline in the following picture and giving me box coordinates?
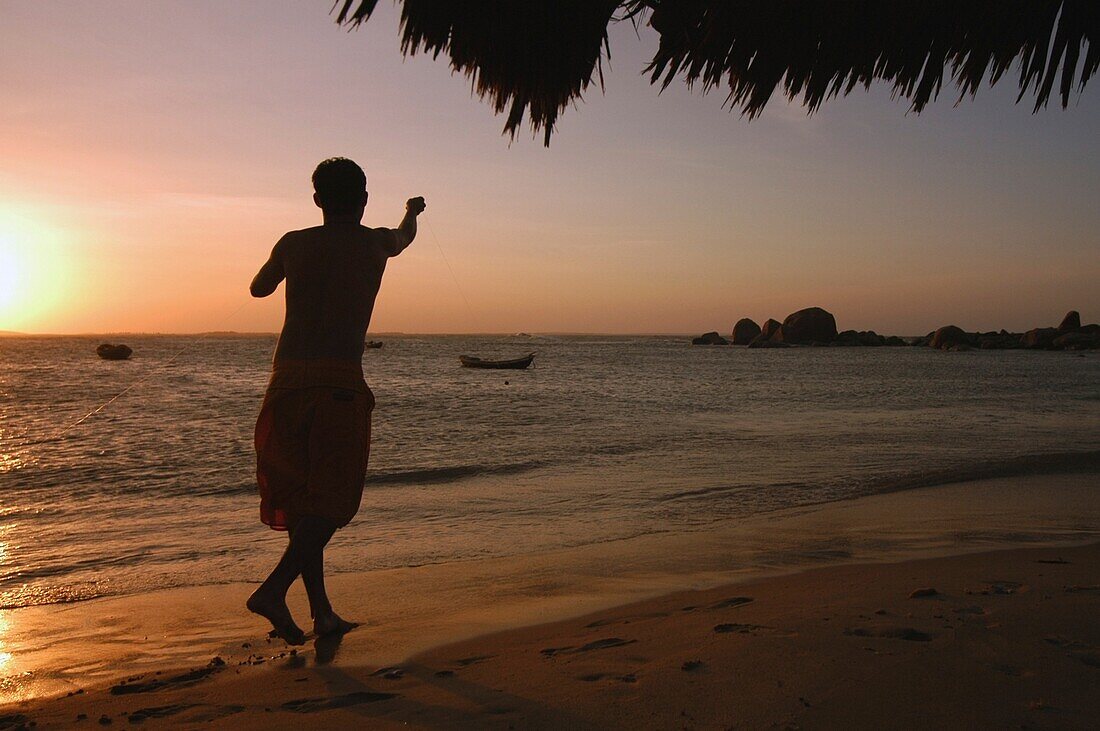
[0,475,1100,728]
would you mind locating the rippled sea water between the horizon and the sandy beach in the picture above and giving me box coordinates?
[0,336,1100,608]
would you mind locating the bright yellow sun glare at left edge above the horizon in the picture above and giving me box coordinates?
[0,209,72,330]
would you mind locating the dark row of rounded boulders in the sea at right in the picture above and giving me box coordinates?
[692,307,1100,351]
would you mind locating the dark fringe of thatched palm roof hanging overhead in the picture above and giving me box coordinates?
[334,0,1100,144]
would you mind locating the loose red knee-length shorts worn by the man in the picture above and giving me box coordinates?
[255,359,374,531]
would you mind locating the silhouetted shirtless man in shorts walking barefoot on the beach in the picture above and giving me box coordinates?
[248,157,425,644]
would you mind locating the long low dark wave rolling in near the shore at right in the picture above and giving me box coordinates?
[658,451,1100,502]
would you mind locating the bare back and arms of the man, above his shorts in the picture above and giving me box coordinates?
[252,198,424,363]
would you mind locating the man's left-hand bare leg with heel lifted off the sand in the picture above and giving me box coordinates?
[246,516,336,644]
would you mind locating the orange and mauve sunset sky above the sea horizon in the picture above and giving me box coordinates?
[0,0,1100,334]
